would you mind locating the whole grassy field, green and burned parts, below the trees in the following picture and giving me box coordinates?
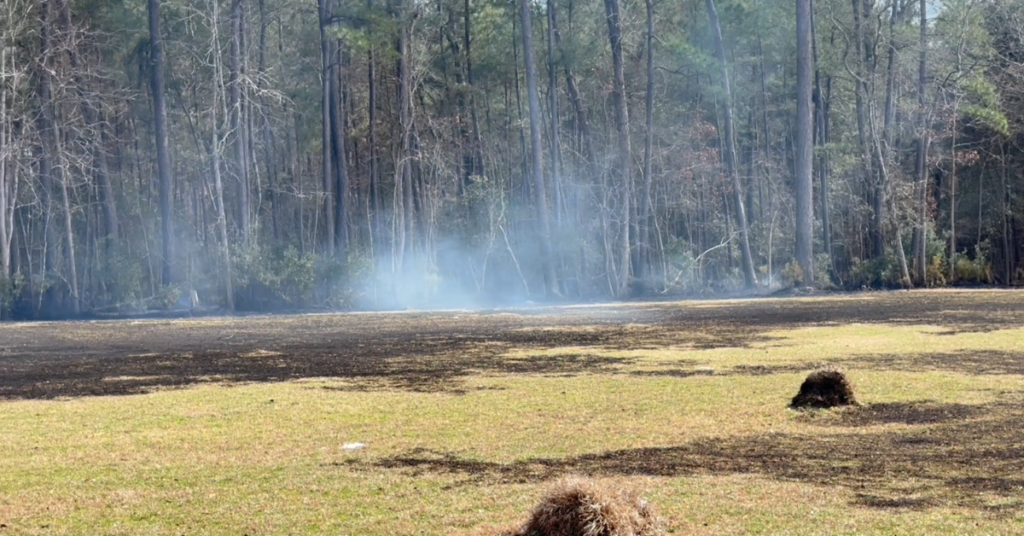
[0,291,1024,536]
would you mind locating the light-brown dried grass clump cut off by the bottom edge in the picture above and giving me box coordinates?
[501,477,665,536]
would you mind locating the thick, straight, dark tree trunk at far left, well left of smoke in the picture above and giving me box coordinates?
[146,0,174,285]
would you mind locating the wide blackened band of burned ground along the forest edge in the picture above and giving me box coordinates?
[0,291,1024,399]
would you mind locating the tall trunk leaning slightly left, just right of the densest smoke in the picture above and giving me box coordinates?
[519,0,561,296]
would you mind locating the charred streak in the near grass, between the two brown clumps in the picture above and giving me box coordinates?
[356,402,1024,513]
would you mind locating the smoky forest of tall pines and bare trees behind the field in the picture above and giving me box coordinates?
[0,0,1024,319]
